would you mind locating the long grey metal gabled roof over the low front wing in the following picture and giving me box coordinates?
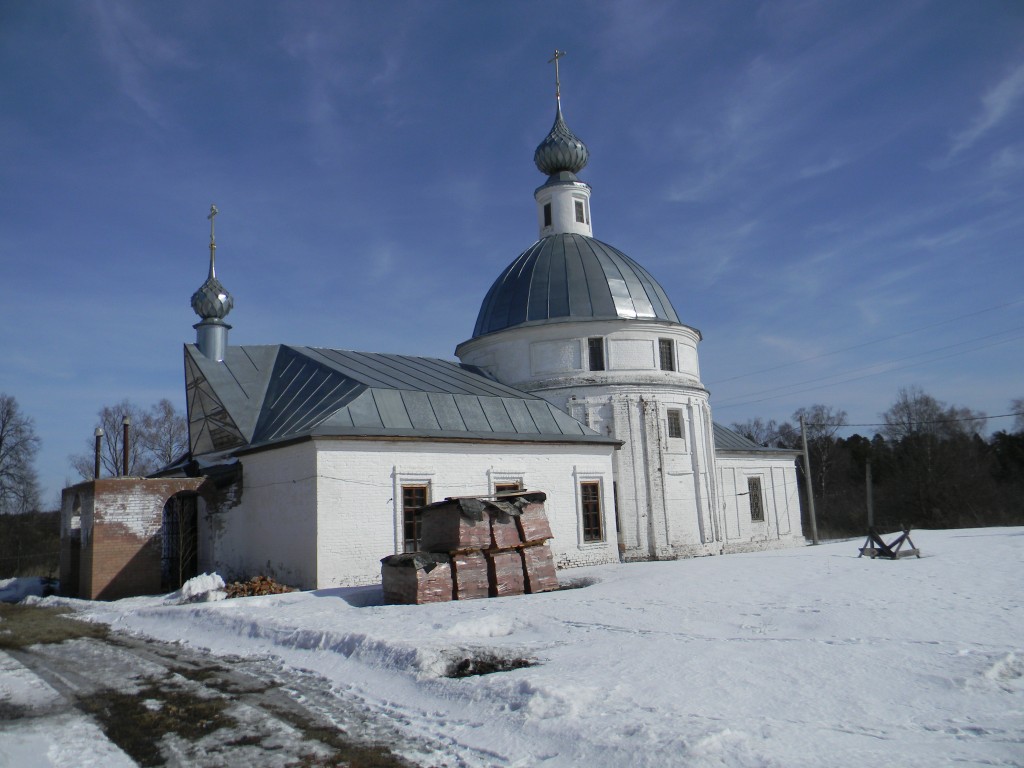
[185,344,615,455]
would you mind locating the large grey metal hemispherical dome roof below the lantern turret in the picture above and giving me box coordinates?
[473,233,679,339]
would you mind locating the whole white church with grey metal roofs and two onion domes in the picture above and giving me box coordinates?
[165,70,804,589]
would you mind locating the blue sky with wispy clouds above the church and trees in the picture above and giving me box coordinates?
[0,0,1024,506]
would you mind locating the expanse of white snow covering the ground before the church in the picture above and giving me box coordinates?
[8,528,1024,768]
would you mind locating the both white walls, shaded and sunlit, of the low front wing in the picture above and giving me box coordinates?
[205,438,618,589]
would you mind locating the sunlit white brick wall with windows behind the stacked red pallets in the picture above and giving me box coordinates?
[316,439,618,587]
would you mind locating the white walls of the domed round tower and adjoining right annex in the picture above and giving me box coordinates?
[456,321,803,560]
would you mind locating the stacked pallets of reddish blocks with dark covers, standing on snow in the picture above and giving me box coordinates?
[381,492,558,605]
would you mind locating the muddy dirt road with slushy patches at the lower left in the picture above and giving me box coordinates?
[0,605,429,768]
